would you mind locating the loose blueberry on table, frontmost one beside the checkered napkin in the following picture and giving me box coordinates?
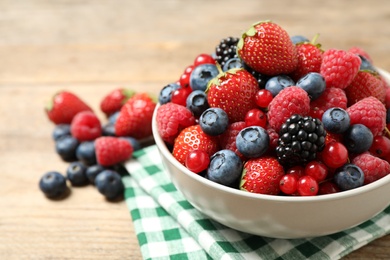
[95,170,124,200]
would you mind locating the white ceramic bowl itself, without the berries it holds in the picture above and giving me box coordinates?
[152,71,390,239]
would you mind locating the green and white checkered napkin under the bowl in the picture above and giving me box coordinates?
[123,145,390,259]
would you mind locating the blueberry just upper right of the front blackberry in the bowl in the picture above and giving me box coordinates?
[322,107,351,134]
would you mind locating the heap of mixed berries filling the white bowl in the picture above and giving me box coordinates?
[156,21,390,196]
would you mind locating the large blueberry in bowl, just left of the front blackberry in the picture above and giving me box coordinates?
[236,126,270,158]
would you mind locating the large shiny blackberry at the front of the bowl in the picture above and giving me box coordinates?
[276,115,326,166]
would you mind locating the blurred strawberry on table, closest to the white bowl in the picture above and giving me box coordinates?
[115,93,156,139]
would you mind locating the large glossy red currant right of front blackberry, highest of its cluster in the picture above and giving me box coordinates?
[321,142,348,168]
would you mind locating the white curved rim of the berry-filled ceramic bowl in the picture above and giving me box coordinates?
[152,69,390,204]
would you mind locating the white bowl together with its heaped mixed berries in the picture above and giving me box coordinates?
[152,21,390,239]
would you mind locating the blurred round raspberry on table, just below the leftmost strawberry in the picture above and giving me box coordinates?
[70,111,102,142]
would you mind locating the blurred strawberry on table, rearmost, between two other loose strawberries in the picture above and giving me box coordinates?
[100,88,135,117]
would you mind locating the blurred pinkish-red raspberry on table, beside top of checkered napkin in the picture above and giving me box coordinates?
[95,136,133,166]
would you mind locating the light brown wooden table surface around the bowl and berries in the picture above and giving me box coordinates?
[0,0,390,259]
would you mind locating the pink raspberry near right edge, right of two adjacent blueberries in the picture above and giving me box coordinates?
[347,97,386,136]
